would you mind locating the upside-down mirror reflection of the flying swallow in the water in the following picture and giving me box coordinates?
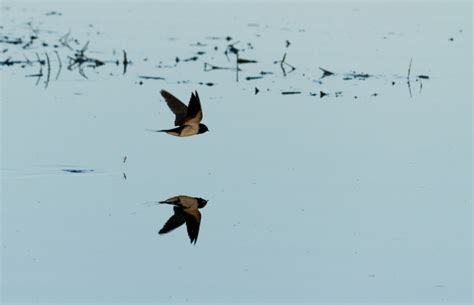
[158,195,207,244]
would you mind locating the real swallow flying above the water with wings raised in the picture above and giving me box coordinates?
[155,90,209,137]
